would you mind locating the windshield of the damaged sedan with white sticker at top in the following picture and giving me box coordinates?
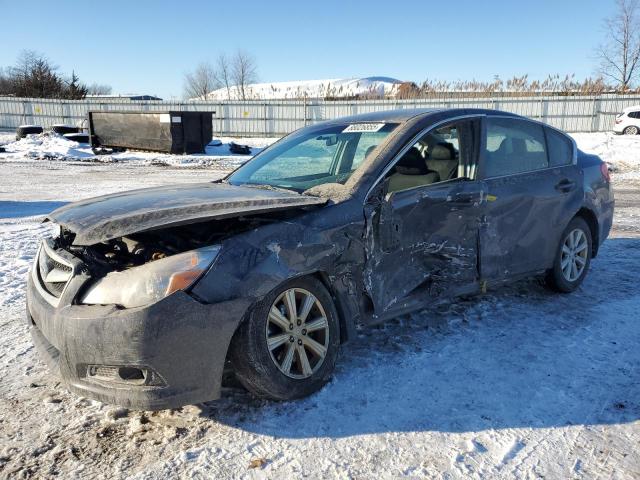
[227,123,397,192]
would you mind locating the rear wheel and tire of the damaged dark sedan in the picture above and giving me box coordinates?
[546,217,593,293]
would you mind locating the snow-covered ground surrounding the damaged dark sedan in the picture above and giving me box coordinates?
[0,129,640,479]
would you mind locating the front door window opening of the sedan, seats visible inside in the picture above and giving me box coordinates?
[387,120,480,192]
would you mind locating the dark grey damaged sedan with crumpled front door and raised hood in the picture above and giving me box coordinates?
[27,109,614,409]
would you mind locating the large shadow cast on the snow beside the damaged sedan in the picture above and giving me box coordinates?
[202,239,640,438]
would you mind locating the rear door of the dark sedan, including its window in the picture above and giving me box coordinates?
[479,116,582,280]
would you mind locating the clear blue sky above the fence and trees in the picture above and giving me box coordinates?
[0,0,614,98]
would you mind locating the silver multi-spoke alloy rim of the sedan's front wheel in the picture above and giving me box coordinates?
[265,288,329,379]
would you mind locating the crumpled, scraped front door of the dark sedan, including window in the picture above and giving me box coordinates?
[364,120,485,317]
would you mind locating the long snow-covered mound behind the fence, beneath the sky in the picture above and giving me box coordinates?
[202,77,402,100]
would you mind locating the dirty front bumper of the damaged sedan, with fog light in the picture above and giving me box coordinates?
[27,275,248,410]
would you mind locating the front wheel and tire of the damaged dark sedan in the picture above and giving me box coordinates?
[229,277,340,400]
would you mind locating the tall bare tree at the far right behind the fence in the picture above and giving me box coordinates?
[597,0,640,91]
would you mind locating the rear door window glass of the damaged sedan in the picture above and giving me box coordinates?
[484,117,549,177]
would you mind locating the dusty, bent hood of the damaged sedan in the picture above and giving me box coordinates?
[47,183,327,245]
